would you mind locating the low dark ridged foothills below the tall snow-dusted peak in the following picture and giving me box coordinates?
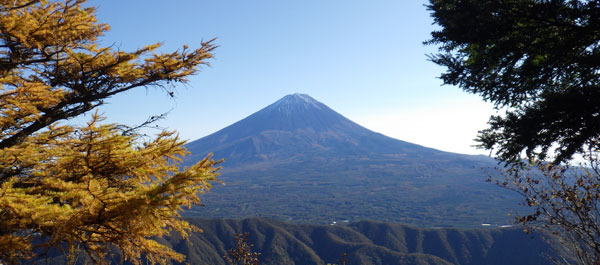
[166,218,556,265]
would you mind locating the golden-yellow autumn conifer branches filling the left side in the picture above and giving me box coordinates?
[0,0,218,264]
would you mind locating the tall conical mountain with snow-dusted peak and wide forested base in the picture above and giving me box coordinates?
[187,94,517,226]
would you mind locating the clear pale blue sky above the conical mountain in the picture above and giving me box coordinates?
[89,0,493,154]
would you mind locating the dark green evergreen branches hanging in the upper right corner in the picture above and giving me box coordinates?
[427,0,600,164]
